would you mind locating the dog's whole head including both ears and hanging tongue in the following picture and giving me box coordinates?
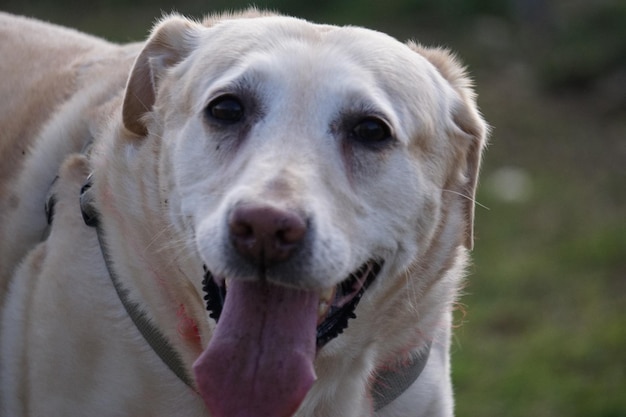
[123,12,486,416]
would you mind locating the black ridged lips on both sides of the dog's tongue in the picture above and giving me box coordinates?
[202,260,384,349]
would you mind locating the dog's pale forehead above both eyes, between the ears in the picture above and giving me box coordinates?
[180,16,448,140]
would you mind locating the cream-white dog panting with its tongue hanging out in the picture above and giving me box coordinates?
[0,9,488,417]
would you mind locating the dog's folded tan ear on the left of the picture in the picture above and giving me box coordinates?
[122,16,197,136]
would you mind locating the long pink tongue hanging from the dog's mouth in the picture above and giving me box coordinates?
[193,281,319,417]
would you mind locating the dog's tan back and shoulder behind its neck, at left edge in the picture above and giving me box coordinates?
[0,13,141,300]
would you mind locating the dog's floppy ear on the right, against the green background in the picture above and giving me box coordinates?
[408,42,489,249]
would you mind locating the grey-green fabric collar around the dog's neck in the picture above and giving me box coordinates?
[80,175,431,411]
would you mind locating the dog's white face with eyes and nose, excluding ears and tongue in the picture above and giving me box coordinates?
[180,30,441,290]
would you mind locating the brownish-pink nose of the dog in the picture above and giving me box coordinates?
[228,204,307,267]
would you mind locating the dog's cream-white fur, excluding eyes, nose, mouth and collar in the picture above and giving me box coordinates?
[0,11,486,417]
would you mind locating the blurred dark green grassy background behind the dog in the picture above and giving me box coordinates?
[0,0,626,417]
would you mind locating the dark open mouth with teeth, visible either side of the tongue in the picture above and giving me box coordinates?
[203,259,384,349]
